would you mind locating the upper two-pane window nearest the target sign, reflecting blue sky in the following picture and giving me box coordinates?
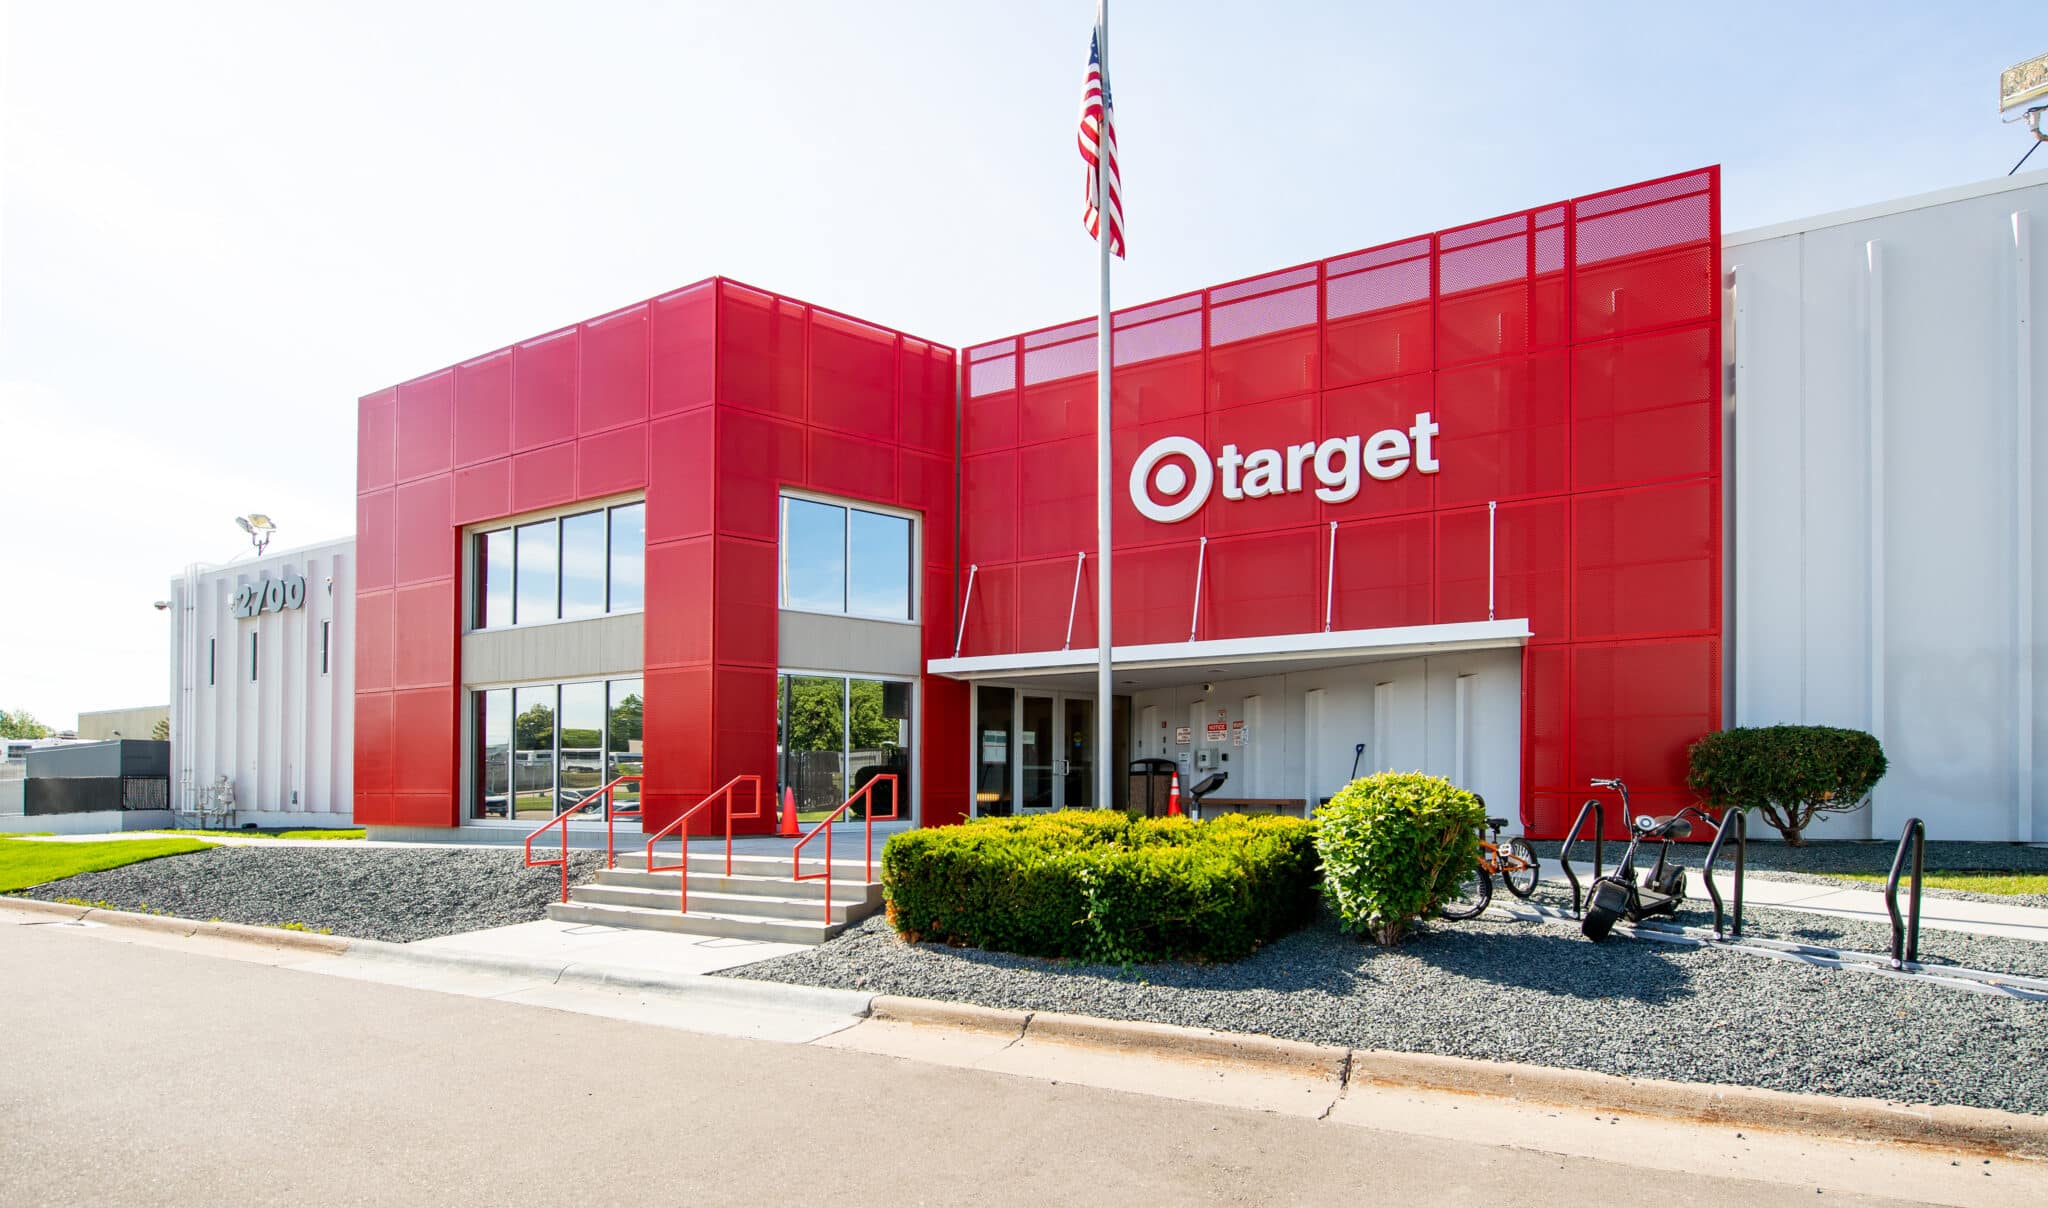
[780,495,915,620]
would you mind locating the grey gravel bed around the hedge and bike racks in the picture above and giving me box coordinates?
[729,889,2048,1112]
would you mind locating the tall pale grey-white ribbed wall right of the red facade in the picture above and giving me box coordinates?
[1724,172,2048,839]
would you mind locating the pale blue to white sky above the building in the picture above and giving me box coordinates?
[0,0,2048,727]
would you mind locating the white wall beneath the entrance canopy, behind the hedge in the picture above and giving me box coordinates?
[1130,649,1522,833]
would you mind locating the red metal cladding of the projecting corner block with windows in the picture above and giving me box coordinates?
[356,278,969,829]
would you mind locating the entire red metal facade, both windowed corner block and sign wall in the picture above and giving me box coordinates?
[354,168,1720,835]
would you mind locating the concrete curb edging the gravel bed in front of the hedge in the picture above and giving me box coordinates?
[870,995,2048,1161]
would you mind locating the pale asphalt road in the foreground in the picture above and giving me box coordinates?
[0,925,1916,1208]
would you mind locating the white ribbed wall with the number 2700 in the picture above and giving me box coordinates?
[170,538,356,825]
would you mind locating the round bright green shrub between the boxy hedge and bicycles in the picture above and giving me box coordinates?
[1315,772,1487,944]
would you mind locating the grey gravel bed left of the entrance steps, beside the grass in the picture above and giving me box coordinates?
[25,846,604,942]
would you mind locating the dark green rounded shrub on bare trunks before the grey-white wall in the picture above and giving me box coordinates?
[1686,725,1884,848]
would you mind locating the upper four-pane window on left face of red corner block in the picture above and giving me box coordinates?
[471,504,647,629]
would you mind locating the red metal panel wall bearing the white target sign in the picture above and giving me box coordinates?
[961,168,1720,835]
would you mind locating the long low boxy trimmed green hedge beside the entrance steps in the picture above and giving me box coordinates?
[883,809,1317,964]
